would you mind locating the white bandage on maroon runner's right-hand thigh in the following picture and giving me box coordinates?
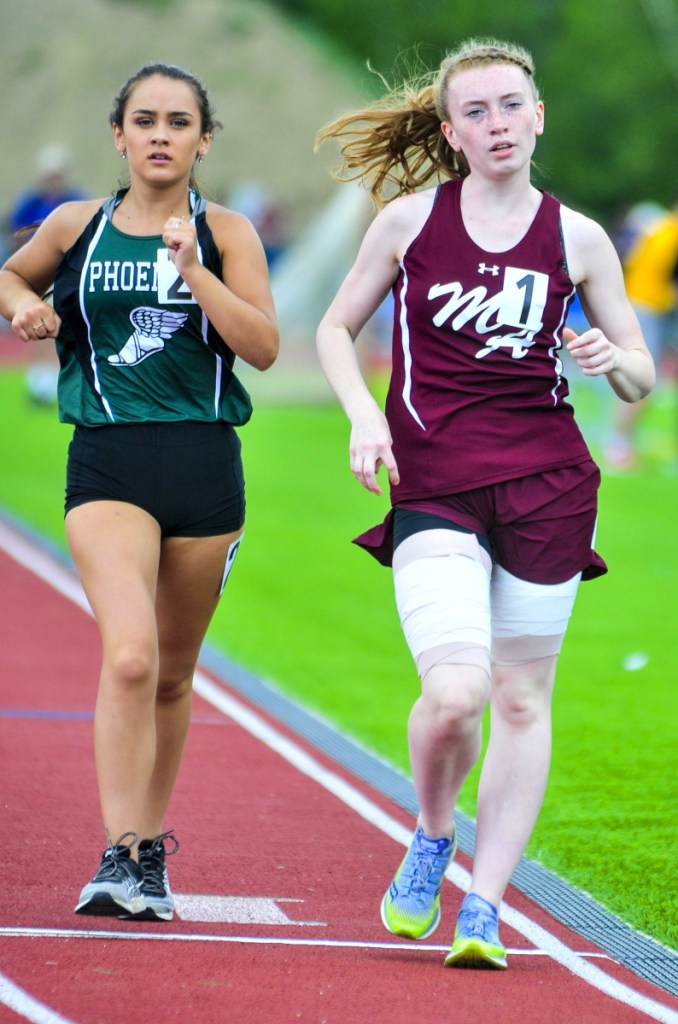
[492,565,582,665]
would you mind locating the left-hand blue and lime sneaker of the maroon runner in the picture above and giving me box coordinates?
[381,828,457,939]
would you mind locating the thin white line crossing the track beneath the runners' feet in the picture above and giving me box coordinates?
[0,928,610,959]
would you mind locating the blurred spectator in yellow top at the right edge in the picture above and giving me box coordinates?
[605,206,678,469]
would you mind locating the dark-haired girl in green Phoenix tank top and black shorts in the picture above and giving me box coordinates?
[0,63,279,920]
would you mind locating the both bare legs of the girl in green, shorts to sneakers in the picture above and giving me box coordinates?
[67,502,240,842]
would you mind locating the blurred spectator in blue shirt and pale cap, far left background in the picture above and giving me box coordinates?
[7,143,85,406]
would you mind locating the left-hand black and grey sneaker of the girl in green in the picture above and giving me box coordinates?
[76,833,145,916]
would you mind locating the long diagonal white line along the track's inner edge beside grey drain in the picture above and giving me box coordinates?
[0,522,678,1024]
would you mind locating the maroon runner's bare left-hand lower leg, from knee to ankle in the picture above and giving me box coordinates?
[409,665,490,837]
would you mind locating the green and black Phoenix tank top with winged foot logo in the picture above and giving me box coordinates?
[54,195,252,426]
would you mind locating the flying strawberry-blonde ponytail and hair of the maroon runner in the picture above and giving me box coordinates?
[315,39,539,209]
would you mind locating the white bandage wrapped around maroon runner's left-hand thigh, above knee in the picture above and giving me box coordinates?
[393,529,492,679]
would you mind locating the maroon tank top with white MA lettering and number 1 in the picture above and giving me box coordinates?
[386,181,590,505]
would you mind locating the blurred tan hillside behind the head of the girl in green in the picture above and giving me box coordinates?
[0,0,361,227]
